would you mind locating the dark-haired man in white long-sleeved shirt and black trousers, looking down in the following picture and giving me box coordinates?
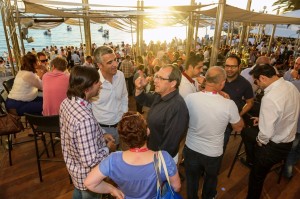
[244,64,300,199]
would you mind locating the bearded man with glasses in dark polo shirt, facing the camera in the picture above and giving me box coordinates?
[223,54,254,152]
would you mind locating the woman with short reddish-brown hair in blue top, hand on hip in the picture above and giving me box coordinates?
[84,111,181,199]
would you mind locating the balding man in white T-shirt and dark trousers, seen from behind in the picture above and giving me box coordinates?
[183,66,244,199]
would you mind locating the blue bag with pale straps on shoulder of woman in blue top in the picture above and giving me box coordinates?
[154,151,183,199]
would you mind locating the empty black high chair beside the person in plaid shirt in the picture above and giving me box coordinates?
[25,113,63,182]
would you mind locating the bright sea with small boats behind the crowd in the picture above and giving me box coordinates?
[0,17,214,56]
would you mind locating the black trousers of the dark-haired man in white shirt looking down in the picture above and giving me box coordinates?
[247,141,293,199]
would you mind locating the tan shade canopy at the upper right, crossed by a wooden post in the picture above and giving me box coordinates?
[198,5,300,24]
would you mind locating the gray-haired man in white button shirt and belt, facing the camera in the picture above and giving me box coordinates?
[92,46,128,144]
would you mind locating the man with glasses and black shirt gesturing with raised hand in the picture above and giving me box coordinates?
[135,65,189,163]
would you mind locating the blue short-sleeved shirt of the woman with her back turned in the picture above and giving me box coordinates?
[99,151,177,199]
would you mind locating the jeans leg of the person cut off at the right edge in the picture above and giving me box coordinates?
[283,133,300,178]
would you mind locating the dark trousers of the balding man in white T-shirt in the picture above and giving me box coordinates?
[183,146,222,199]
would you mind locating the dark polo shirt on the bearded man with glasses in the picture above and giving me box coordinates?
[223,75,254,112]
